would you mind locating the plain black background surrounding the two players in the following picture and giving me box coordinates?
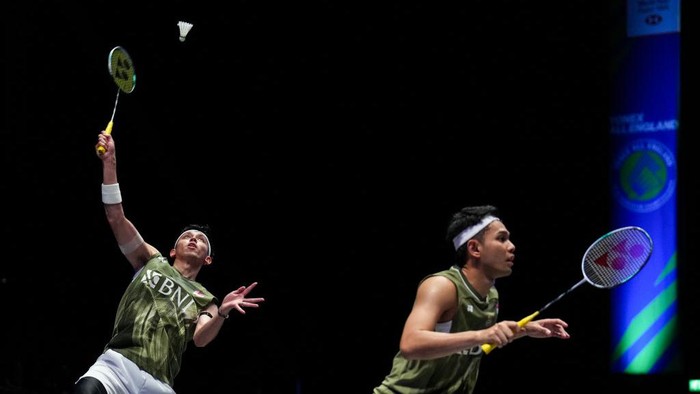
[0,0,700,394]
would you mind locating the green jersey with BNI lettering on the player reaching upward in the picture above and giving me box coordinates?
[105,254,216,387]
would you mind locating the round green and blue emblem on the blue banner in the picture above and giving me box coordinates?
[612,139,676,212]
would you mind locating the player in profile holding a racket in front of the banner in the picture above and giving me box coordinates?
[373,205,569,394]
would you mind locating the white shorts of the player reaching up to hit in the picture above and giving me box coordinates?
[78,349,175,394]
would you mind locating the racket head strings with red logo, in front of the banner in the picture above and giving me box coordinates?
[583,228,652,288]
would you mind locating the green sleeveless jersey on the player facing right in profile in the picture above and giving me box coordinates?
[373,266,498,394]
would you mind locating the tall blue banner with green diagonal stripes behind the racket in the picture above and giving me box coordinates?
[610,0,683,374]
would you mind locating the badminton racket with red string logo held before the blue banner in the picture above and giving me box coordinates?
[481,226,654,354]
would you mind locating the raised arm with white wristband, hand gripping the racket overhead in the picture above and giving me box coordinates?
[95,131,158,270]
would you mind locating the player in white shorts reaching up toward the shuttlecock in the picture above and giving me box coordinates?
[73,132,264,394]
